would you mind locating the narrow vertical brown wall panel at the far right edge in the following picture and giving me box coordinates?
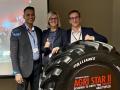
[112,0,120,52]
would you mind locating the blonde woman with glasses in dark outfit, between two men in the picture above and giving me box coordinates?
[43,12,67,65]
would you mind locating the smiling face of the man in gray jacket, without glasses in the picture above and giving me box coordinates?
[23,9,35,25]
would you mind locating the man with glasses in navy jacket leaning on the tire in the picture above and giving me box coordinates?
[67,10,108,43]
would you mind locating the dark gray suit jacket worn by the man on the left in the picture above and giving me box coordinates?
[10,24,42,77]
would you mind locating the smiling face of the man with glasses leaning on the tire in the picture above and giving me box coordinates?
[69,12,80,28]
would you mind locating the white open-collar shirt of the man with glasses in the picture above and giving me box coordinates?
[70,27,82,43]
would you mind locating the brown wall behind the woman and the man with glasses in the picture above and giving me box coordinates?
[49,0,120,52]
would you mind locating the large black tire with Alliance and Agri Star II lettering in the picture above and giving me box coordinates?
[41,41,120,90]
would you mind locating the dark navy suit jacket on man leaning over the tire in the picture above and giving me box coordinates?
[67,27,108,43]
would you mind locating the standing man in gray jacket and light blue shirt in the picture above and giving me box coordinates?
[10,6,42,90]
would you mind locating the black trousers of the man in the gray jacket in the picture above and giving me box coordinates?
[17,61,41,90]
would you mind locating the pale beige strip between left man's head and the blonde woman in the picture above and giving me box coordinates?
[31,0,48,29]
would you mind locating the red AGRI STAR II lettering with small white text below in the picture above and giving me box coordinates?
[74,74,112,90]
